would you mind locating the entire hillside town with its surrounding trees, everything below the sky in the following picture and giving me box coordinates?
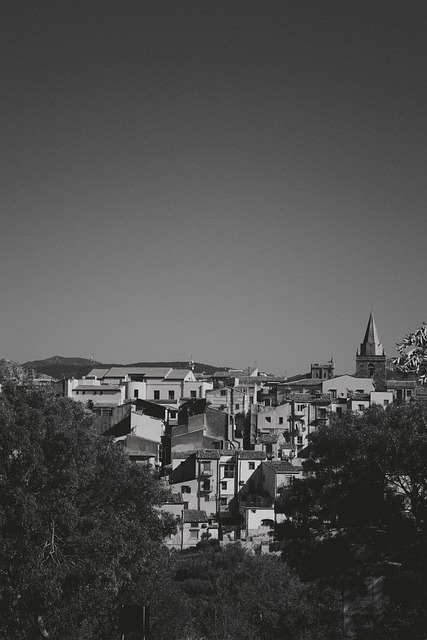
[0,312,427,640]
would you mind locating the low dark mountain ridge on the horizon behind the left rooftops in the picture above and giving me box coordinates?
[22,356,224,380]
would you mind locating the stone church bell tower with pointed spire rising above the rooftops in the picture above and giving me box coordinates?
[356,311,386,391]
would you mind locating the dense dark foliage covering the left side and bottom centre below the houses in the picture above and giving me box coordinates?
[0,376,339,640]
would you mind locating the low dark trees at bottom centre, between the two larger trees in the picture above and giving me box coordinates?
[177,544,341,640]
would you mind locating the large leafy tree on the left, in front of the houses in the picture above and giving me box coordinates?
[0,381,174,640]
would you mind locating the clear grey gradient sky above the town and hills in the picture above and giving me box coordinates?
[0,0,427,375]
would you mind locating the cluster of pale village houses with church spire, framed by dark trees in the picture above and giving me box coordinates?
[32,313,427,549]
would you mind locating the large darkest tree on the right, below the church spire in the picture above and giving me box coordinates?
[277,402,427,638]
